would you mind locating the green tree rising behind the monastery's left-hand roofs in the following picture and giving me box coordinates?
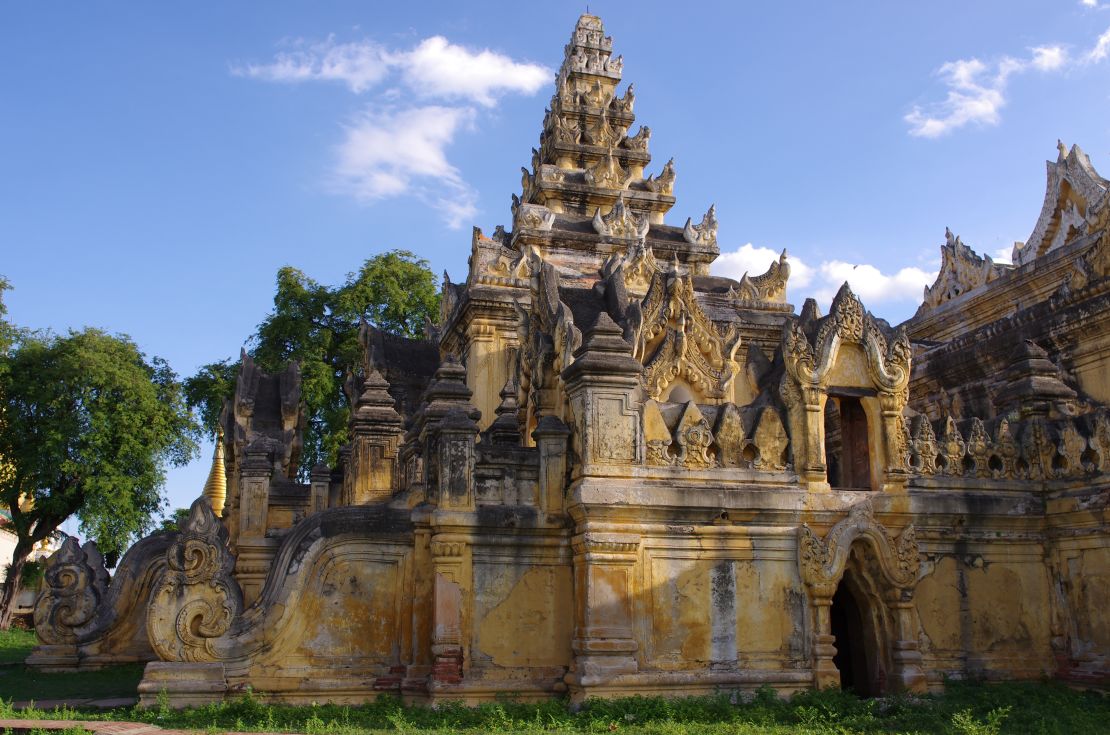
[185,250,440,476]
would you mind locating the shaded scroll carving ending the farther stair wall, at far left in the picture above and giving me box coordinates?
[33,536,108,645]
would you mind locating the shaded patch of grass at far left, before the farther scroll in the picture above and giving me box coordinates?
[0,664,143,702]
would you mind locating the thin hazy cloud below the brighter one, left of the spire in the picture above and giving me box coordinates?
[332,105,477,228]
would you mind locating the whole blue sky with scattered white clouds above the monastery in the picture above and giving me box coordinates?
[0,0,1110,526]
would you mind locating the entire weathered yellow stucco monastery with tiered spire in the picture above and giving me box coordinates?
[29,14,1110,706]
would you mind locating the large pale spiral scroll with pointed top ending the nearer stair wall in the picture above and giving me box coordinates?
[147,497,243,662]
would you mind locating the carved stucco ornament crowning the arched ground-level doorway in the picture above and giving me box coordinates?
[798,502,921,597]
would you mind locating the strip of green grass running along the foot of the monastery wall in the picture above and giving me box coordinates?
[0,683,1110,735]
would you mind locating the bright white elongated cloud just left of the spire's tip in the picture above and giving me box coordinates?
[398,36,553,107]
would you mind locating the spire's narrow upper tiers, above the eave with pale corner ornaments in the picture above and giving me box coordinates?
[522,14,675,224]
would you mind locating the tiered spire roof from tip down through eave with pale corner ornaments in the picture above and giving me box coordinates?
[513,14,718,283]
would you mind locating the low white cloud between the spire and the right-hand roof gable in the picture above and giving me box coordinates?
[712,243,937,309]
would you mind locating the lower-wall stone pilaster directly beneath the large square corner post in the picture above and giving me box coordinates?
[566,532,639,687]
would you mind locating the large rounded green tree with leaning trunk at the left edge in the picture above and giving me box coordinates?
[0,329,199,628]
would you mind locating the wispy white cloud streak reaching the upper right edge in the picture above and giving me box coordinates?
[904,25,1110,138]
